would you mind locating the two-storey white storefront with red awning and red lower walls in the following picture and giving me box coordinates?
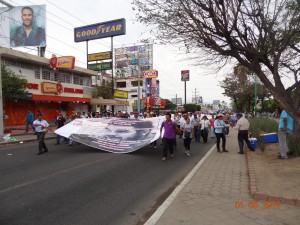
[0,47,97,126]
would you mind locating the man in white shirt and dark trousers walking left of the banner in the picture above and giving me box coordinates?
[33,114,52,155]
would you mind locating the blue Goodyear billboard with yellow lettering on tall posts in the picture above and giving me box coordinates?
[74,18,126,42]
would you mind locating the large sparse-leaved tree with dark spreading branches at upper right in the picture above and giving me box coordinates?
[133,0,300,129]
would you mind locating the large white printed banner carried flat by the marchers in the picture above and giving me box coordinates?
[55,117,161,153]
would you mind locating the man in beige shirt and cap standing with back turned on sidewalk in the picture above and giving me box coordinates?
[235,113,255,154]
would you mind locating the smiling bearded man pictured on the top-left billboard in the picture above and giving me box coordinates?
[11,6,46,47]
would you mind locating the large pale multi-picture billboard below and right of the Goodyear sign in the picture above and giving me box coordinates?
[115,44,153,78]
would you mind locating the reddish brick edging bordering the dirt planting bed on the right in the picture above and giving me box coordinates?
[245,149,300,207]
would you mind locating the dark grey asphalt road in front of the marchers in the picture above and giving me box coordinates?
[0,139,214,225]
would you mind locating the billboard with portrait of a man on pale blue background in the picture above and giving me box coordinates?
[0,5,47,47]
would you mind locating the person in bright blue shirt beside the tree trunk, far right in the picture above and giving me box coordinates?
[278,110,294,159]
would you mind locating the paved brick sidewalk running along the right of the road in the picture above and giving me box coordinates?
[145,129,300,225]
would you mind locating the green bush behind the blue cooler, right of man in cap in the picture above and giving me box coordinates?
[249,117,278,151]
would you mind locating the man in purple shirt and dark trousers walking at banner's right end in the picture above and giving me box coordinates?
[160,113,177,161]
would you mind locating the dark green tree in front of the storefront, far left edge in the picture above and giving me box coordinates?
[1,66,28,100]
